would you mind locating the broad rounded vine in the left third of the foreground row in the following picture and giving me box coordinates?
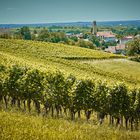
[21,69,44,113]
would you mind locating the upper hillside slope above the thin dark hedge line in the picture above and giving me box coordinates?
[0,39,123,59]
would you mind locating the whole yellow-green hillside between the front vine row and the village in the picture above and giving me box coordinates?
[0,39,140,86]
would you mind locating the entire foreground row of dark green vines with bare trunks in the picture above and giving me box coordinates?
[0,65,140,130]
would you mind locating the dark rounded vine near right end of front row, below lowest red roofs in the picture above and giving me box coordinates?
[109,83,130,126]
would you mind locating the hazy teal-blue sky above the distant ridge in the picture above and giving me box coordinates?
[0,0,140,24]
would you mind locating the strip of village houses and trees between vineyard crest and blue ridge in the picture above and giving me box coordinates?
[0,21,140,55]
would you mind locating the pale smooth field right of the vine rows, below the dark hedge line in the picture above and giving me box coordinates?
[79,59,140,84]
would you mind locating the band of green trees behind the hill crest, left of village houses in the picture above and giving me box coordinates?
[14,27,96,49]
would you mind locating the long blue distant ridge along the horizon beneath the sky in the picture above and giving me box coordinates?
[0,20,140,28]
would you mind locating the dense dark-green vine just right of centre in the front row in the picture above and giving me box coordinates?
[73,80,95,120]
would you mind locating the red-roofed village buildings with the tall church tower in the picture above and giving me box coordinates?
[66,21,140,55]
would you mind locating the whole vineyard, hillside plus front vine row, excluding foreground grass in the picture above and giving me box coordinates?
[0,39,140,139]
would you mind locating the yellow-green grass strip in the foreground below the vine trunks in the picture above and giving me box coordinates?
[0,111,140,140]
